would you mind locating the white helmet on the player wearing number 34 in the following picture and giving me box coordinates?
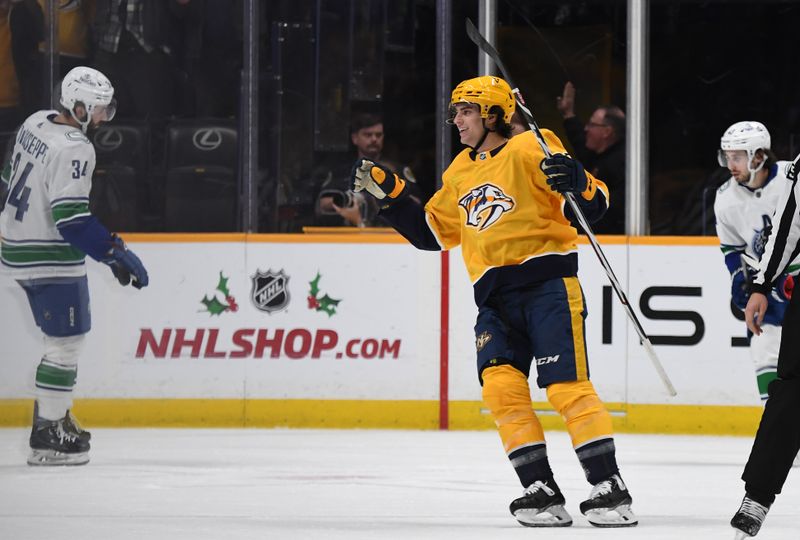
[59,66,117,133]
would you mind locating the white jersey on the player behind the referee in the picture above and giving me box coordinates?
[714,161,800,273]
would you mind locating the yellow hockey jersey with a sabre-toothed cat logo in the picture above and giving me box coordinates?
[425,130,609,305]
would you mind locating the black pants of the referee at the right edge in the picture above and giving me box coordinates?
[742,291,800,505]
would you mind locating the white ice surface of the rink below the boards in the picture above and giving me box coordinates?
[0,429,800,540]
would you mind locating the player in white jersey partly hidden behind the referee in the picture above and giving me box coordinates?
[714,121,800,401]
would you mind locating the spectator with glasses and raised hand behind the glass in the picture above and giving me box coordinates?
[557,82,625,234]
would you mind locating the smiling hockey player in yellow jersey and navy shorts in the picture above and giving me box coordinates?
[353,76,637,527]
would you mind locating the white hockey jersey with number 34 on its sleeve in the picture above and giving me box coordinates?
[0,111,96,279]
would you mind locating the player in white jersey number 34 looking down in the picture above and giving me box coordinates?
[0,67,149,465]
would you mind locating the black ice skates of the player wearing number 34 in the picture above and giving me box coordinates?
[28,416,89,466]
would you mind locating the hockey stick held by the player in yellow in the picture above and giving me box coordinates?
[467,19,677,396]
